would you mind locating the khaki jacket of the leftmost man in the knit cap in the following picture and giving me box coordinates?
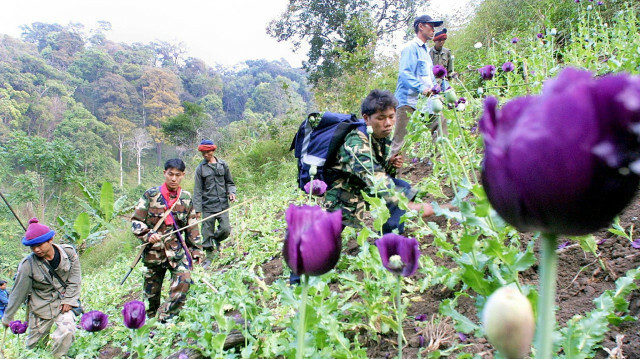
[2,243,82,324]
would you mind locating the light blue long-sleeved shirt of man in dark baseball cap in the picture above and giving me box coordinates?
[395,37,436,109]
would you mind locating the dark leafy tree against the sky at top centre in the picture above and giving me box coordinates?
[267,0,418,84]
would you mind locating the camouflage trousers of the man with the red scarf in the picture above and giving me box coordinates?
[144,260,193,320]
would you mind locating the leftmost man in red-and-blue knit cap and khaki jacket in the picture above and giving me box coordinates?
[2,218,81,358]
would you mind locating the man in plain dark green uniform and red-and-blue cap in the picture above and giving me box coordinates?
[193,140,236,268]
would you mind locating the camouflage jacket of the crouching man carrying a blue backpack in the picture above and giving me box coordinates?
[325,129,417,227]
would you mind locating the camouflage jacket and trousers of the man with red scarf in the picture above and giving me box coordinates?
[131,187,203,320]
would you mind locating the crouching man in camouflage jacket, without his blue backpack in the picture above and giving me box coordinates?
[325,90,433,233]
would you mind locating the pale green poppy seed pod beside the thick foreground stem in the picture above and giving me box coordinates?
[482,287,536,359]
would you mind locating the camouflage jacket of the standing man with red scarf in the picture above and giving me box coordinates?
[131,187,203,268]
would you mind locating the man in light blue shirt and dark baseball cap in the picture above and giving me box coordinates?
[391,15,443,156]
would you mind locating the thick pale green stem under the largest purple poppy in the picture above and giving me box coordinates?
[536,233,558,358]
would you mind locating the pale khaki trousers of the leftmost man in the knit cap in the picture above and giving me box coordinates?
[27,311,76,358]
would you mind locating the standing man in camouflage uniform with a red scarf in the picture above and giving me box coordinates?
[131,159,203,321]
